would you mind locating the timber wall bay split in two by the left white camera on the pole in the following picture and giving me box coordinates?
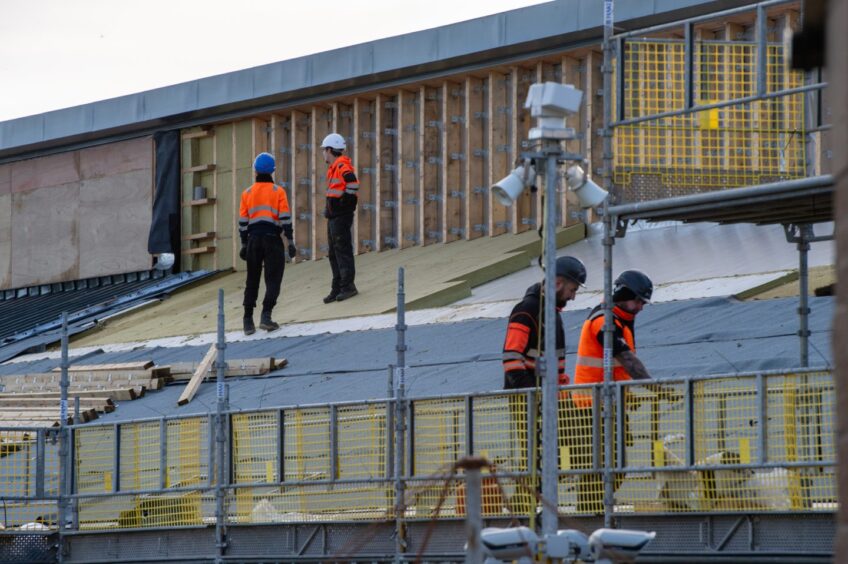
[509,67,537,233]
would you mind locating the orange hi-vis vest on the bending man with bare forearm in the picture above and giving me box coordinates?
[571,306,636,407]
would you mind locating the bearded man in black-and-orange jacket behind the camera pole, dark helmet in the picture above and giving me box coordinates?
[503,256,586,513]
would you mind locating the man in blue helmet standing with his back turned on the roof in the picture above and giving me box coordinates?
[238,153,297,335]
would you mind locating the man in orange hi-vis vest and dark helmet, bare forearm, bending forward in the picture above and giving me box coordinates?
[566,270,654,514]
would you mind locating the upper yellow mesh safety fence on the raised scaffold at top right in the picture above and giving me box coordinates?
[614,38,807,201]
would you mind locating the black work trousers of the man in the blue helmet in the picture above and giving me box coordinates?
[244,235,286,311]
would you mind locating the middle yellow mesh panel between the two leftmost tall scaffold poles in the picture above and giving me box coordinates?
[120,421,161,490]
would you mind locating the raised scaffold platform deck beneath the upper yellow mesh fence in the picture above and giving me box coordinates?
[609,175,834,225]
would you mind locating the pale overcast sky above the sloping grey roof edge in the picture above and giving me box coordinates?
[0,0,543,121]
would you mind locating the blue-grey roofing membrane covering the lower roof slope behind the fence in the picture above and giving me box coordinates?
[0,297,834,422]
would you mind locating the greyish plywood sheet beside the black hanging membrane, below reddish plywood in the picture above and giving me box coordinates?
[79,169,152,278]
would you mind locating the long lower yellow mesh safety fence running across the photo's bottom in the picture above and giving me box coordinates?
[0,370,837,533]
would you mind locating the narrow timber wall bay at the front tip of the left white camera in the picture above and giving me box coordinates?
[486,72,513,236]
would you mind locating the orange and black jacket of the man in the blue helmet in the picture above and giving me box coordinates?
[239,174,293,244]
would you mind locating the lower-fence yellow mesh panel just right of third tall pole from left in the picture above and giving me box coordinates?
[412,398,466,475]
